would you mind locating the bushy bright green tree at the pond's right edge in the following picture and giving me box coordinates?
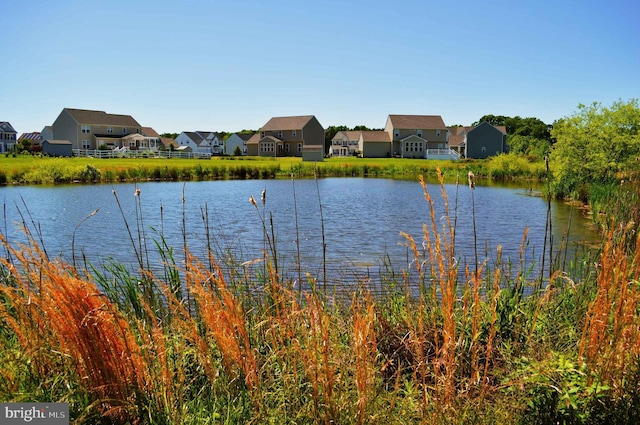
[550,99,640,200]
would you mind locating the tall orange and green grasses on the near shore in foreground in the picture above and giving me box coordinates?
[0,175,640,424]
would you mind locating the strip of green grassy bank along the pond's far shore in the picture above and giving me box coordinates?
[0,155,545,184]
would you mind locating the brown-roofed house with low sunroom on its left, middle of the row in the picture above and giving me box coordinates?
[247,115,324,160]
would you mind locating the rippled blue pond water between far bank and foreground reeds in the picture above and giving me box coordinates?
[0,178,599,286]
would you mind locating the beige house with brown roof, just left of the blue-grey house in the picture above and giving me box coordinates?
[384,115,449,158]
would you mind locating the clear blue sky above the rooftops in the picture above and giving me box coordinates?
[0,0,640,133]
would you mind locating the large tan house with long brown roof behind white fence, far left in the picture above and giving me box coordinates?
[51,108,142,149]
